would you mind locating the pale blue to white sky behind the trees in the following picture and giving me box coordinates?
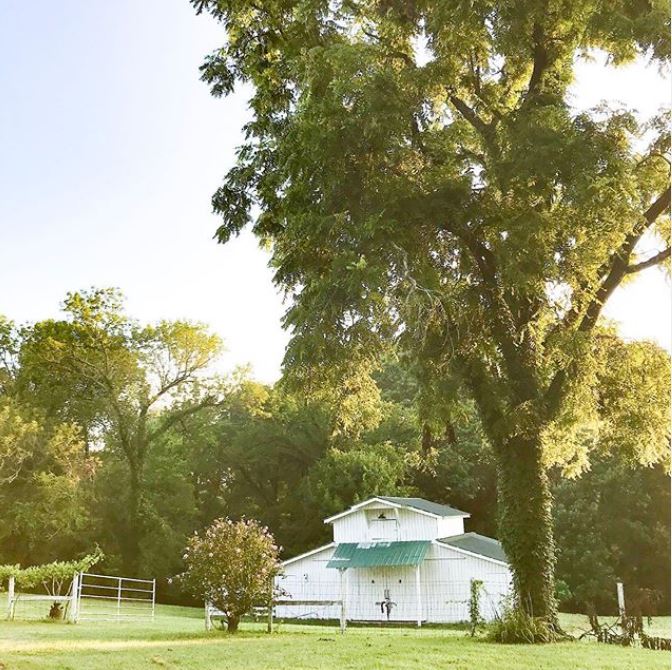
[0,0,672,382]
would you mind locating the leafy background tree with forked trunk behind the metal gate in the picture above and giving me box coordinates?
[6,289,225,574]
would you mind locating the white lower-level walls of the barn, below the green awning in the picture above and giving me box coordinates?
[276,543,510,623]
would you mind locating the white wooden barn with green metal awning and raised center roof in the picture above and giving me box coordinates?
[275,497,511,625]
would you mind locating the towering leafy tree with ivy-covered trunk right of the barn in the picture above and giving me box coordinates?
[192,0,670,621]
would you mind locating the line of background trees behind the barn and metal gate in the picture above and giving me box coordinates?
[0,289,670,610]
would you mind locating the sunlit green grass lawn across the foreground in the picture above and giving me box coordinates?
[0,606,670,670]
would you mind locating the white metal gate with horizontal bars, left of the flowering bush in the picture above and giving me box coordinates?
[75,572,156,621]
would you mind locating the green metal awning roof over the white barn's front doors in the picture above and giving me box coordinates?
[327,540,431,568]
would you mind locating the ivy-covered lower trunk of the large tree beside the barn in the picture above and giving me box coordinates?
[497,437,557,628]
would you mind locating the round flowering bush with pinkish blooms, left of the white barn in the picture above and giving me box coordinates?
[182,519,280,633]
